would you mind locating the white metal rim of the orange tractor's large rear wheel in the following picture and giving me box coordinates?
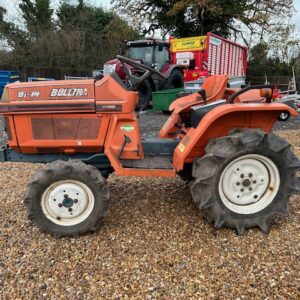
[219,154,280,215]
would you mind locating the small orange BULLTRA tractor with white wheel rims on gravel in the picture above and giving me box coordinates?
[0,56,300,236]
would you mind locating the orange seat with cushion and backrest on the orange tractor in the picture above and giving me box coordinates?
[169,75,229,111]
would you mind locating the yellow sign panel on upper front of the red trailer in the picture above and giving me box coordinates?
[171,36,206,52]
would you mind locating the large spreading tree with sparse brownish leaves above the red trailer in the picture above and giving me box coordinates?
[112,0,294,46]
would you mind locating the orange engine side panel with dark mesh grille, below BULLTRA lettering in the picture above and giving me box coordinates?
[9,113,110,154]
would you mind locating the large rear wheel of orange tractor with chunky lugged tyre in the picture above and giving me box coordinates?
[190,129,300,234]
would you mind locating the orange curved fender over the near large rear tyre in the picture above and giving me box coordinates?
[173,103,298,172]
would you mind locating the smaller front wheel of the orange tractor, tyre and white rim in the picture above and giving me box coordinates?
[24,160,109,237]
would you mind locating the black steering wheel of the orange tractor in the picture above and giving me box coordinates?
[117,55,166,87]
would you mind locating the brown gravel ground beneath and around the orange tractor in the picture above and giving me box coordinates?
[0,114,300,299]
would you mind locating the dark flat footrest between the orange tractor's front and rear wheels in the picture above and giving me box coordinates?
[122,155,174,170]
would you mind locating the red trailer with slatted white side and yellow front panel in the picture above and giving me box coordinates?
[170,32,248,81]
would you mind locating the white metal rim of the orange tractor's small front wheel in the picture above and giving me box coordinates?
[41,180,95,226]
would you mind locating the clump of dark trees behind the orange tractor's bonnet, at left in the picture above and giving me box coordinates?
[0,0,138,69]
